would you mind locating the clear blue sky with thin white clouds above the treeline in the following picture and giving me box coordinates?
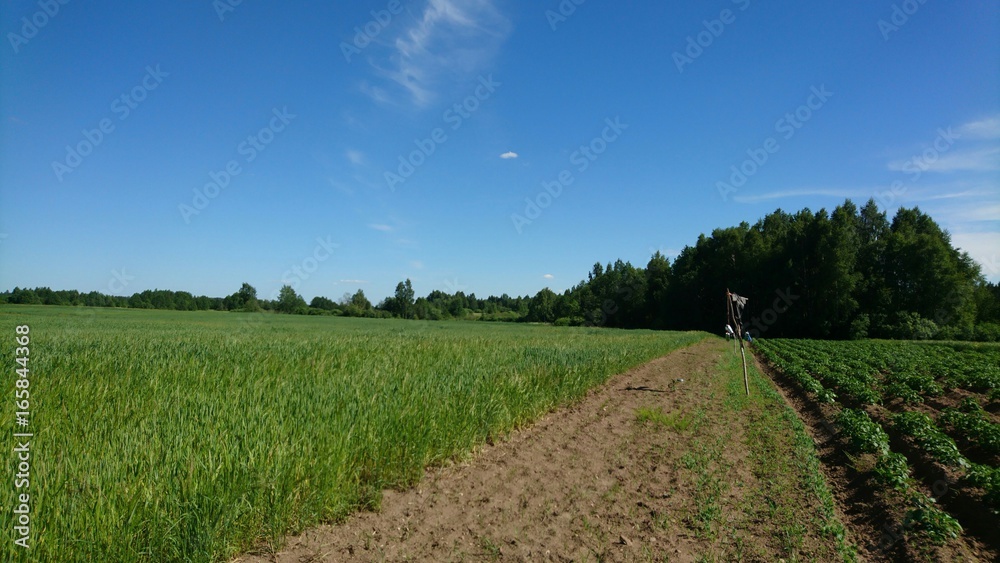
[0,0,1000,300]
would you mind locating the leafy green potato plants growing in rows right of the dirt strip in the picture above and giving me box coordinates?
[757,339,1000,544]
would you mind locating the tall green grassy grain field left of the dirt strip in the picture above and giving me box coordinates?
[0,306,704,561]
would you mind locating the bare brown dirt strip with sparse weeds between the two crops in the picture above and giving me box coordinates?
[241,339,840,563]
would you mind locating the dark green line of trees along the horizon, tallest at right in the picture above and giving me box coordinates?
[7,200,1000,341]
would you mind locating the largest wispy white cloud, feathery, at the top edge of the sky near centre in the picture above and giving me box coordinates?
[362,0,510,106]
